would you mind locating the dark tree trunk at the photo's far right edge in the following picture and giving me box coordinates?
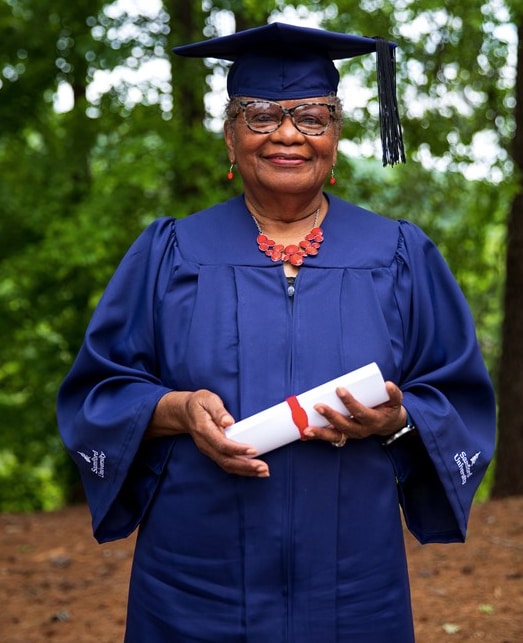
[492,25,523,498]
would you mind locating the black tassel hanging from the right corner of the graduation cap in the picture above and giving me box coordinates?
[375,38,405,166]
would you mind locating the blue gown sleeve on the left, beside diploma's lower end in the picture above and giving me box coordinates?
[57,218,174,542]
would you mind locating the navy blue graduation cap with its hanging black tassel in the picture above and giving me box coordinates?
[173,22,405,165]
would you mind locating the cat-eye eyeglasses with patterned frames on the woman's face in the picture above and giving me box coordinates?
[240,100,336,136]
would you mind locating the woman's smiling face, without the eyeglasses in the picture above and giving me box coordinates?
[225,97,339,194]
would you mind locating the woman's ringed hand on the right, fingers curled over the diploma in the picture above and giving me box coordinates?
[304,382,407,442]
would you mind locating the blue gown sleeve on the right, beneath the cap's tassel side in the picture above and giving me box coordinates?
[387,222,496,543]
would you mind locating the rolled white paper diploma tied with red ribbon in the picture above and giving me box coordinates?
[225,362,389,455]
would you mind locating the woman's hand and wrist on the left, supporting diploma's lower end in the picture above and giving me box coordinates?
[144,389,269,478]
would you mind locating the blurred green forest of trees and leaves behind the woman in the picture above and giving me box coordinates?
[0,0,523,511]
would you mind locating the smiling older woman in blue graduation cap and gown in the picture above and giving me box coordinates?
[58,24,495,643]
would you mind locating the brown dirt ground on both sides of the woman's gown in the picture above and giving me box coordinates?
[0,497,523,643]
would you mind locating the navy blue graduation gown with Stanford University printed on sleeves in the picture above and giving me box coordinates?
[58,196,495,643]
